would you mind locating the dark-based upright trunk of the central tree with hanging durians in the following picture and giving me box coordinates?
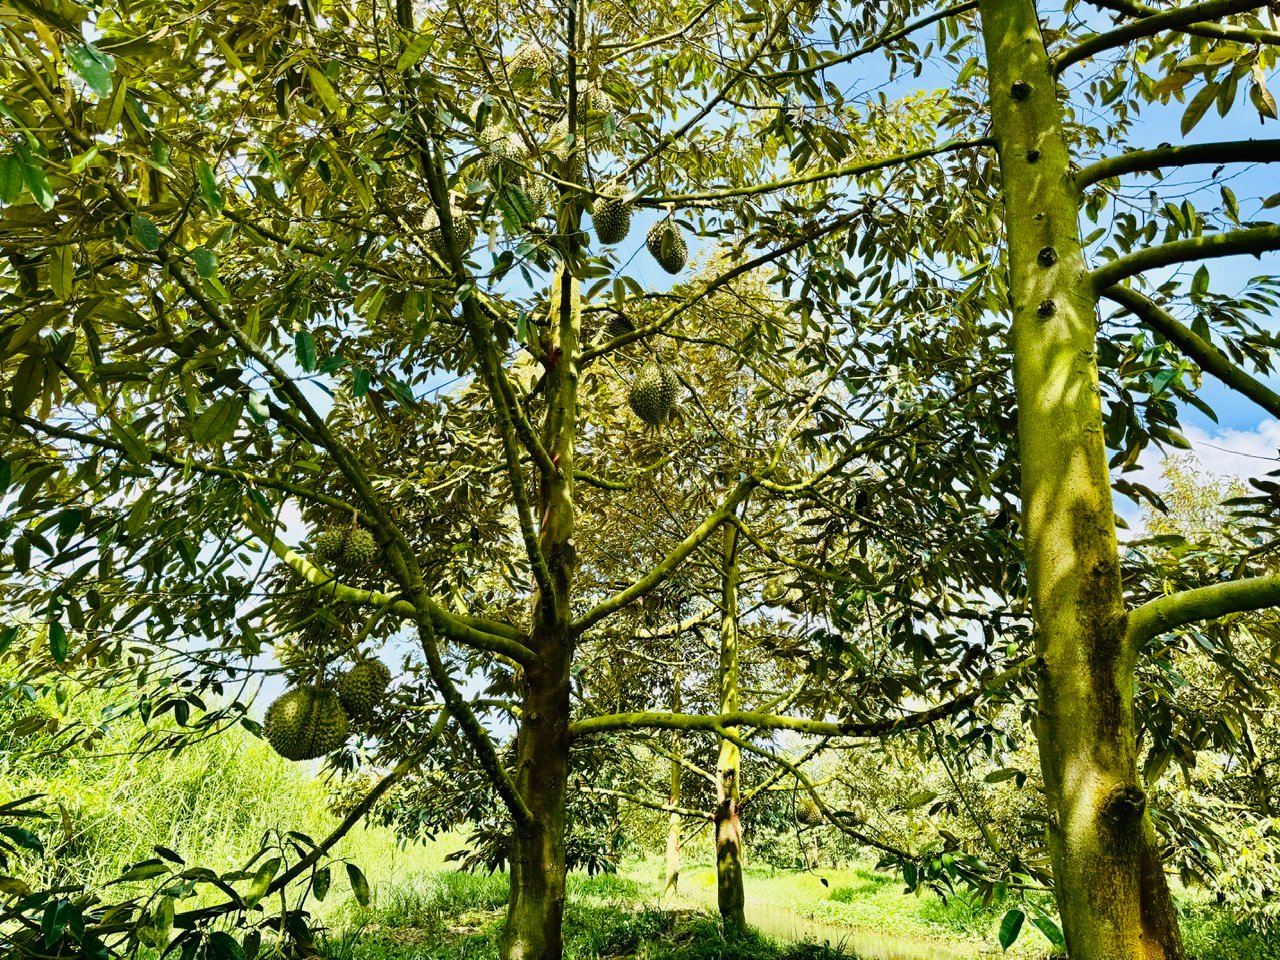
[499,256,581,960]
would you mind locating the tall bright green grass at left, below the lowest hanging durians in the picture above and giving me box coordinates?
[0,675,334,886]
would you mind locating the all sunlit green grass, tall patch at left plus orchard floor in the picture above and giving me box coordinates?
[0,698,1280,960]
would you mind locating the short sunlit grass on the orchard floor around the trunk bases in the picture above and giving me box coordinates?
[320,836,1280,960]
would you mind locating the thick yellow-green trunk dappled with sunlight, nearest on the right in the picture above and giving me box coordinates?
[979,0,1183,960]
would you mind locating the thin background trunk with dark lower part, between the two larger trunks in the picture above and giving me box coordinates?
[716,525,746,933]
